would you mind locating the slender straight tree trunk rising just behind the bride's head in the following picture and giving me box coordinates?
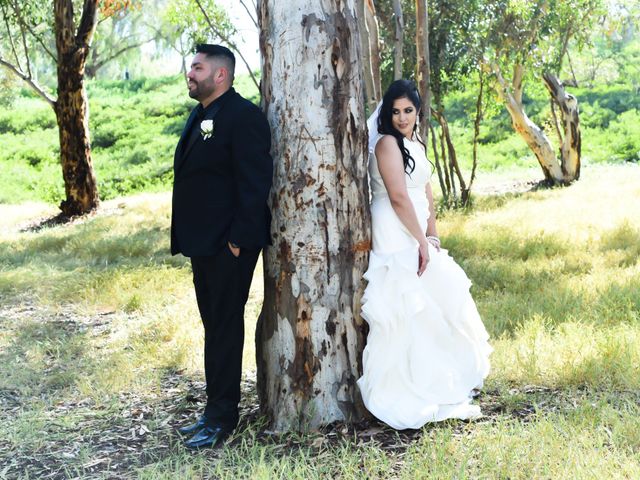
[416,0,431,145]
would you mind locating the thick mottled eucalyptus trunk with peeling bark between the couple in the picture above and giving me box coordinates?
[256,0,370,430]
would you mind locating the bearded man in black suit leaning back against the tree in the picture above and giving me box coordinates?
[171,45,273,448]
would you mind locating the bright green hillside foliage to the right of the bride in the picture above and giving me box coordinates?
[444,81,640,171]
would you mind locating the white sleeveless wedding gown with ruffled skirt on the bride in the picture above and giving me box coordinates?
[358,136,491,430]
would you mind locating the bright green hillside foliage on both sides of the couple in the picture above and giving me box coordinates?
[0,71,640,203]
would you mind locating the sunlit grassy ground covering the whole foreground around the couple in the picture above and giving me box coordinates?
[0,164,640,479]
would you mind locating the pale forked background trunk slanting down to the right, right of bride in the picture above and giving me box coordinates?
[491,64,565,184]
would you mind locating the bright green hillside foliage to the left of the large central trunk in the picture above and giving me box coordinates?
[0,72,259,203]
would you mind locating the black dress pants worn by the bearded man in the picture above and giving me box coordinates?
[191,245,260,430]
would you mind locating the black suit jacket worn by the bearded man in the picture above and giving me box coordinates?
[171,88,273,257]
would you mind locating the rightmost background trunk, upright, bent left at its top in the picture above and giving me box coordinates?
[542,73,582,183]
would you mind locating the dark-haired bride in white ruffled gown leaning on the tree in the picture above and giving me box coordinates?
[358,80,491,430]
